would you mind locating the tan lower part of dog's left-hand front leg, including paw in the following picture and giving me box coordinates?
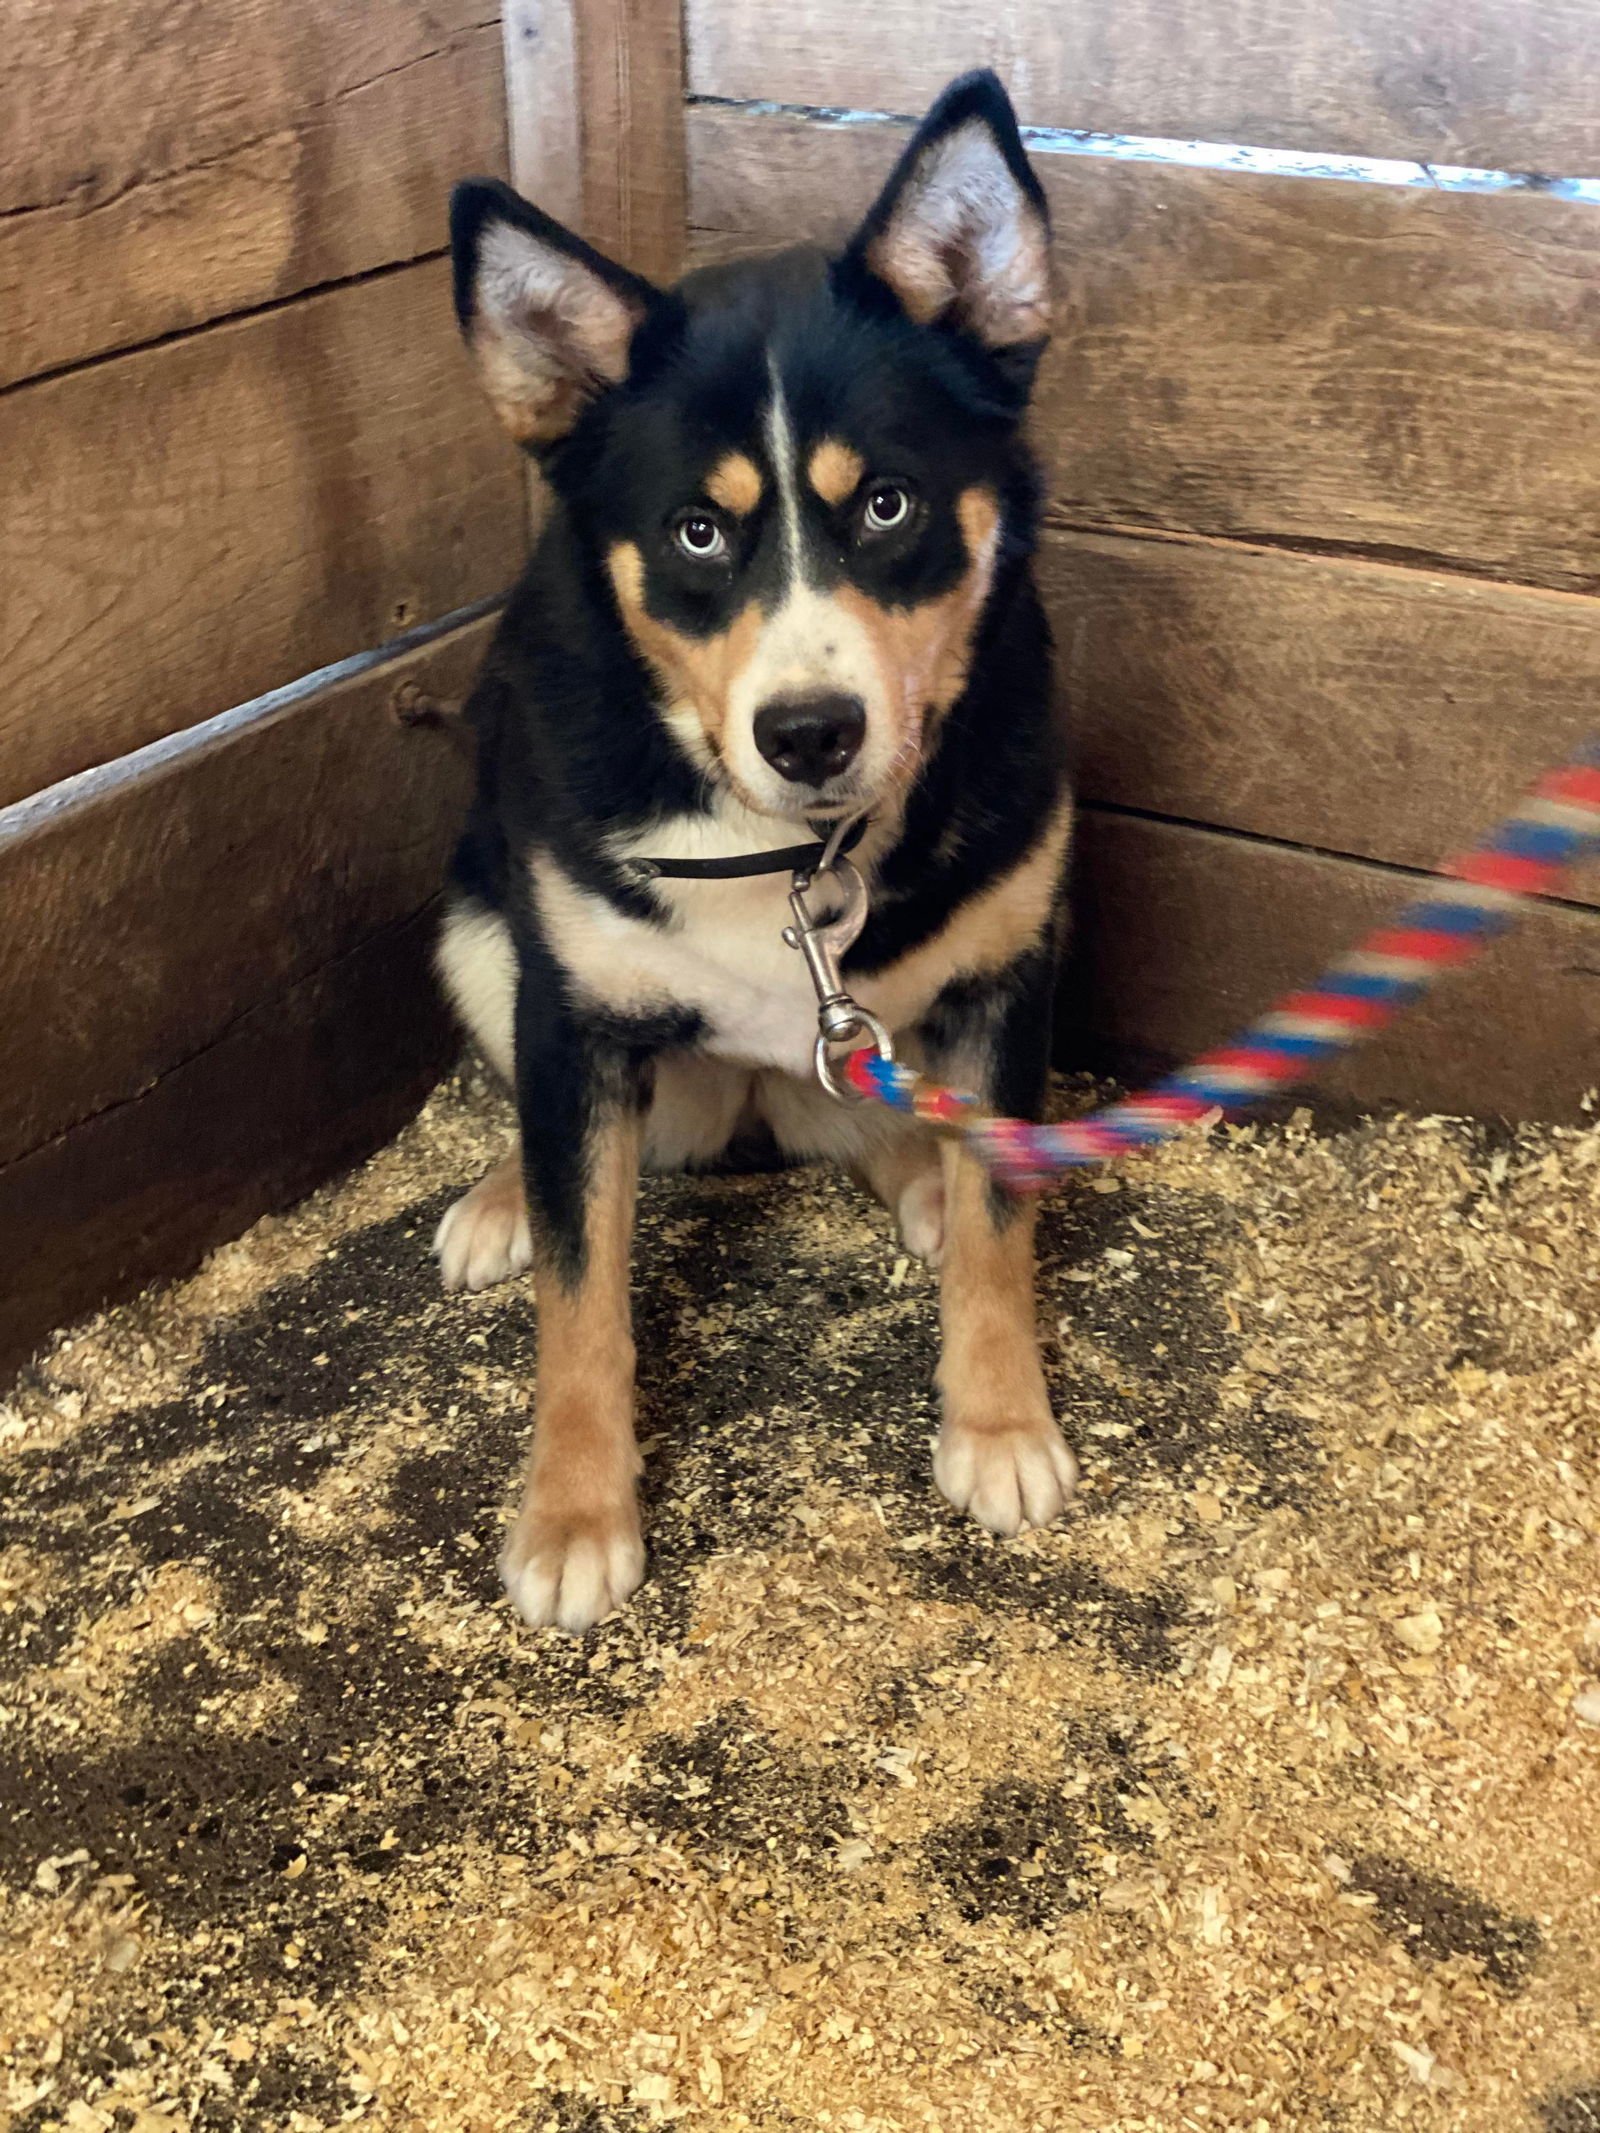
[499,1111,644,1632]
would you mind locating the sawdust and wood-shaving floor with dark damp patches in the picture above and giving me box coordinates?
[0,1066,1600,2133]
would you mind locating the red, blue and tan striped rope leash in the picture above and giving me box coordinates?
[838,736,1600,1192]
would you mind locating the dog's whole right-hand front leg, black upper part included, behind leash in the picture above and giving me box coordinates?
[930,953,1077,1534]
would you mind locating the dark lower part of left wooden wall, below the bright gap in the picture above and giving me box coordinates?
[0,619,493,1372]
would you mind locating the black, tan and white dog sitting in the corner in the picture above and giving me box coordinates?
[435,73,1077,1632]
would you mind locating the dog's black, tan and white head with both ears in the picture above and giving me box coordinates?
[452,75,1050,819]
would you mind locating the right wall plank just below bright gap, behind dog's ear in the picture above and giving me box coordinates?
[689,109,1600,591]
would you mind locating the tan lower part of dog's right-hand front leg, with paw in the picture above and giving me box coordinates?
[934,1145,1077,1534]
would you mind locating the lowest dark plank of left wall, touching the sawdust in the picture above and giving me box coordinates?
[0,911,457,1384]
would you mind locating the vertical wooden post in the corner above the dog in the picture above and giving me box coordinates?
[506,0,685,282]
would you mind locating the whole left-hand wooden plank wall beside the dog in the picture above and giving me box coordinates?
[0,0,525,1361]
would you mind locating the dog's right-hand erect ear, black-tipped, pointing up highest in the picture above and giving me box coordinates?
[845,70,1050,350]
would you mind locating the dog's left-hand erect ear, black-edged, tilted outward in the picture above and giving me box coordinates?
[450,177,659,446]
